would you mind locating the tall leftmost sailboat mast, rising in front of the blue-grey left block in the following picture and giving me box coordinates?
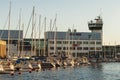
[7,2,11,57]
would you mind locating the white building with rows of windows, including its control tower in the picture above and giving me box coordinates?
[45,17,103,57]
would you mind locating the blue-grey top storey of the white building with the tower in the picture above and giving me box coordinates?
[46,31,101,40]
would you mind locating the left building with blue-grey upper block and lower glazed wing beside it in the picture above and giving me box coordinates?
[0,30,44,57]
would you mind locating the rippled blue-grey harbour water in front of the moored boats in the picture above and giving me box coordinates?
[0,62,120,80]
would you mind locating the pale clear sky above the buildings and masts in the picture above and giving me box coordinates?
[0,0,120,45]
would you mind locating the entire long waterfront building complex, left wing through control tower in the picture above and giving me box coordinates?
[0,16,103,58]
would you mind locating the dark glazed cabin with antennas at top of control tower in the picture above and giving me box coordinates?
[88,16,103,34]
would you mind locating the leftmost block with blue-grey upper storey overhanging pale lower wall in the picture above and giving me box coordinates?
[0,30,23,57]
